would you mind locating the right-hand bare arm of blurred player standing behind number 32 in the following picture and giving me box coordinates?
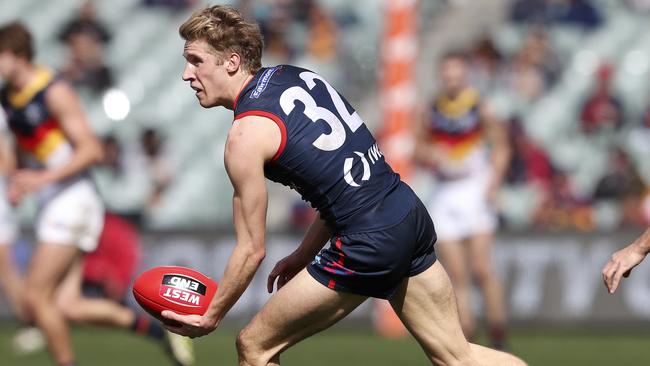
[480,103,512,201]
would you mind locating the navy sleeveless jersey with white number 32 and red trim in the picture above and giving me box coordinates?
[234,65,413,233]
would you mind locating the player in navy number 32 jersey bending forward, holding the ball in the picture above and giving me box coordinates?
[163,6,524,366]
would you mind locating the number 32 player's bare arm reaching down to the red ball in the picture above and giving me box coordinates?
[162,116,281,337]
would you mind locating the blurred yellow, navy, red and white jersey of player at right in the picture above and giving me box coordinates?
[427,88,489,179]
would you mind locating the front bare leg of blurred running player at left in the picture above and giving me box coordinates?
[25,243,79,365]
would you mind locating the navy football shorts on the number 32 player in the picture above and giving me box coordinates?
[307,198,436,299]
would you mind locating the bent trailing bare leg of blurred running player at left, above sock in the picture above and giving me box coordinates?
[57,260,136,328]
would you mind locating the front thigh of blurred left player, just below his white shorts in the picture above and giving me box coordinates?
[27,243,79,296]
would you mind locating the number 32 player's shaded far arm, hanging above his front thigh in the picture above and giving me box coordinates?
[266,217,331,293]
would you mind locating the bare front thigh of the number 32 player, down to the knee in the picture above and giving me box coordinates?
[240,270,366,355]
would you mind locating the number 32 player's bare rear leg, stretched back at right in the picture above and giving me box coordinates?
[391,262,526,366]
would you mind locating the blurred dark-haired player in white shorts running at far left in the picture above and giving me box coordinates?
[0,23,192,366]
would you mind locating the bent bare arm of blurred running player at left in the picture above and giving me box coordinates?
[10,81,103,201]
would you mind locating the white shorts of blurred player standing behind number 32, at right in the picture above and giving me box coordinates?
[427,174,497,242]
